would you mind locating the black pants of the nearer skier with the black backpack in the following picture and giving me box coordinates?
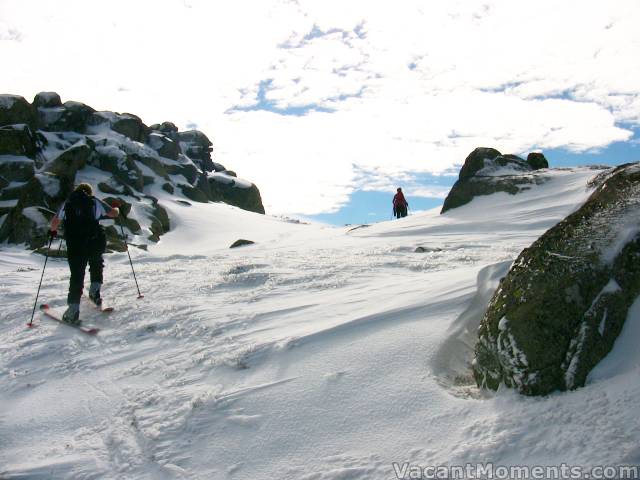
[66,231,106,304]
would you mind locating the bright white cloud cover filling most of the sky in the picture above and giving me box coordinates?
[0,0,640,214]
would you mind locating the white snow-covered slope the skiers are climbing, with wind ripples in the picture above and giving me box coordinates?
[0,169,640,479]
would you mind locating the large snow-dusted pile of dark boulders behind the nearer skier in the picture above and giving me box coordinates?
[0,92,264,250]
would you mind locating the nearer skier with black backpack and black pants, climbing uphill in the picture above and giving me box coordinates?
[49,183,120,325]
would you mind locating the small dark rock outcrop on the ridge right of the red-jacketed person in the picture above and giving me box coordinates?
[440,147,549,213]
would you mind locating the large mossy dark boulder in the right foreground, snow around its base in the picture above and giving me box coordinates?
[473,163,640,395]
